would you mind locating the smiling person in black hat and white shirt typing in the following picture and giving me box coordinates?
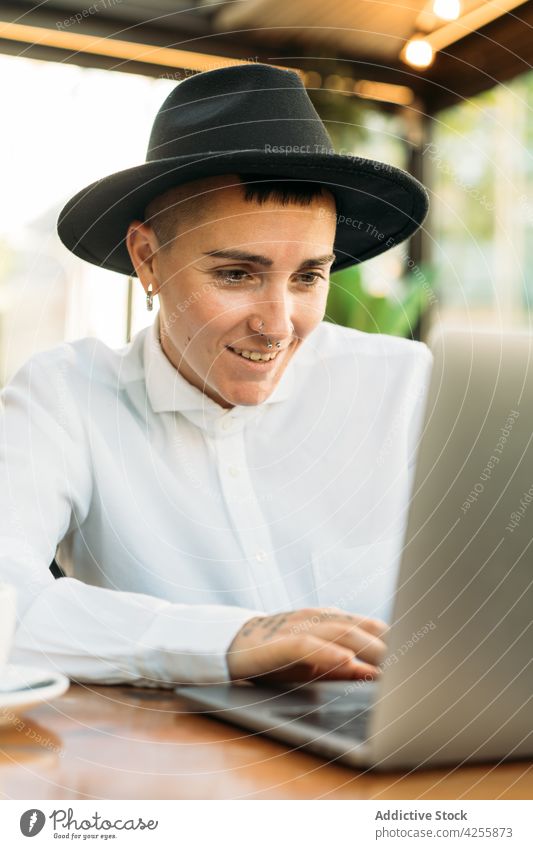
[0,65,431,687]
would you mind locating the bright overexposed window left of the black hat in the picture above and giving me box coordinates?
[0,55,176,384]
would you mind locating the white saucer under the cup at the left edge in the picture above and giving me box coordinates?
[0,664,70,725]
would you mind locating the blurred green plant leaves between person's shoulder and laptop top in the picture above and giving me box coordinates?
[324,265,435,338]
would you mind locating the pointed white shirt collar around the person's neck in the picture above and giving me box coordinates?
[144,311,295,418]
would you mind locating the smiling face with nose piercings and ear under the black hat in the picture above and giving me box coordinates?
[126,176,335,408]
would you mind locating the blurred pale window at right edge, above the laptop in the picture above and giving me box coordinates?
[424,72,533,327]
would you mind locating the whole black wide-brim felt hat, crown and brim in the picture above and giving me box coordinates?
[58,64,428,274]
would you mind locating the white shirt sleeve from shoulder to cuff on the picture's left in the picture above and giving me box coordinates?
[0,346,261,687]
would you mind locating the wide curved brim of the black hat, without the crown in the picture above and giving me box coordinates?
[57,150,429,274]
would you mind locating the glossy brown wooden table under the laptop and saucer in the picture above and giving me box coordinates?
[0,685,533,800]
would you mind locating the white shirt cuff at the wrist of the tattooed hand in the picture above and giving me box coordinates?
[137,602,266,687]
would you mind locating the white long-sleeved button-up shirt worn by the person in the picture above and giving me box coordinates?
[0,314,431,686]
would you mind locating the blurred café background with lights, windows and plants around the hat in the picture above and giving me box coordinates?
[0,0,533,385]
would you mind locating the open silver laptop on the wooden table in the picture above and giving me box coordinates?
[176,328,533,770]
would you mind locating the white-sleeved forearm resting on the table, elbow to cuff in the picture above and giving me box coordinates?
[11,578,257,687]
